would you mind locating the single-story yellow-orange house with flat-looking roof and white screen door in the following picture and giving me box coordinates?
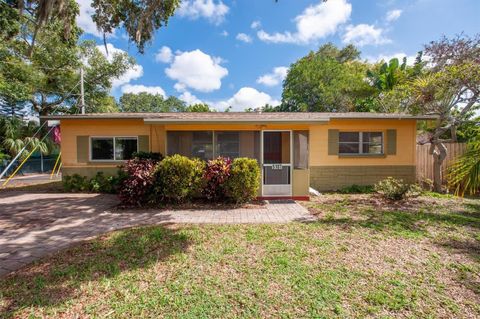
[44,112,435,199]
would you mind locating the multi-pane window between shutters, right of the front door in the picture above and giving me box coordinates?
[338,132,383,154]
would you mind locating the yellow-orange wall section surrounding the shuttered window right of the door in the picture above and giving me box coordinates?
[309,119,416,166]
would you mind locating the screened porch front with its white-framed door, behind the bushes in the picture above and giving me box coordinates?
[166,130,309,196]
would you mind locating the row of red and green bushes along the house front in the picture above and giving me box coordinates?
[64,153,260,206]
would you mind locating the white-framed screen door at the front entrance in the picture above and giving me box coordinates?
[261,131,293,196]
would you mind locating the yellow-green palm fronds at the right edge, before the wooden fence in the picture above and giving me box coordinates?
[447,138,480,196]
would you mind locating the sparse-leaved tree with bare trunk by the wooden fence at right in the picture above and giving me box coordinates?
[410,34,480,192]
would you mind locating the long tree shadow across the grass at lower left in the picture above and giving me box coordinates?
[0,225,191,318]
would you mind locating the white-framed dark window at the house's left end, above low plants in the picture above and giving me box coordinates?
[91,137,138,161]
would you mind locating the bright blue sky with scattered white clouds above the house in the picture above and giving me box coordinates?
[78,0,480,110]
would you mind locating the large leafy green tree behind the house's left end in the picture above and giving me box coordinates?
[0,15,134,115]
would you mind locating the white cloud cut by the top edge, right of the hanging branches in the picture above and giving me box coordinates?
[177,0,230,24]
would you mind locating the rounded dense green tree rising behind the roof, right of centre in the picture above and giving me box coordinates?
[279,43,375,112]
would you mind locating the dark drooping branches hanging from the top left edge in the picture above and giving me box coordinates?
[0,0,181,54]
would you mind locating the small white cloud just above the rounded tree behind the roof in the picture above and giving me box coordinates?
[342,24,391,46]
